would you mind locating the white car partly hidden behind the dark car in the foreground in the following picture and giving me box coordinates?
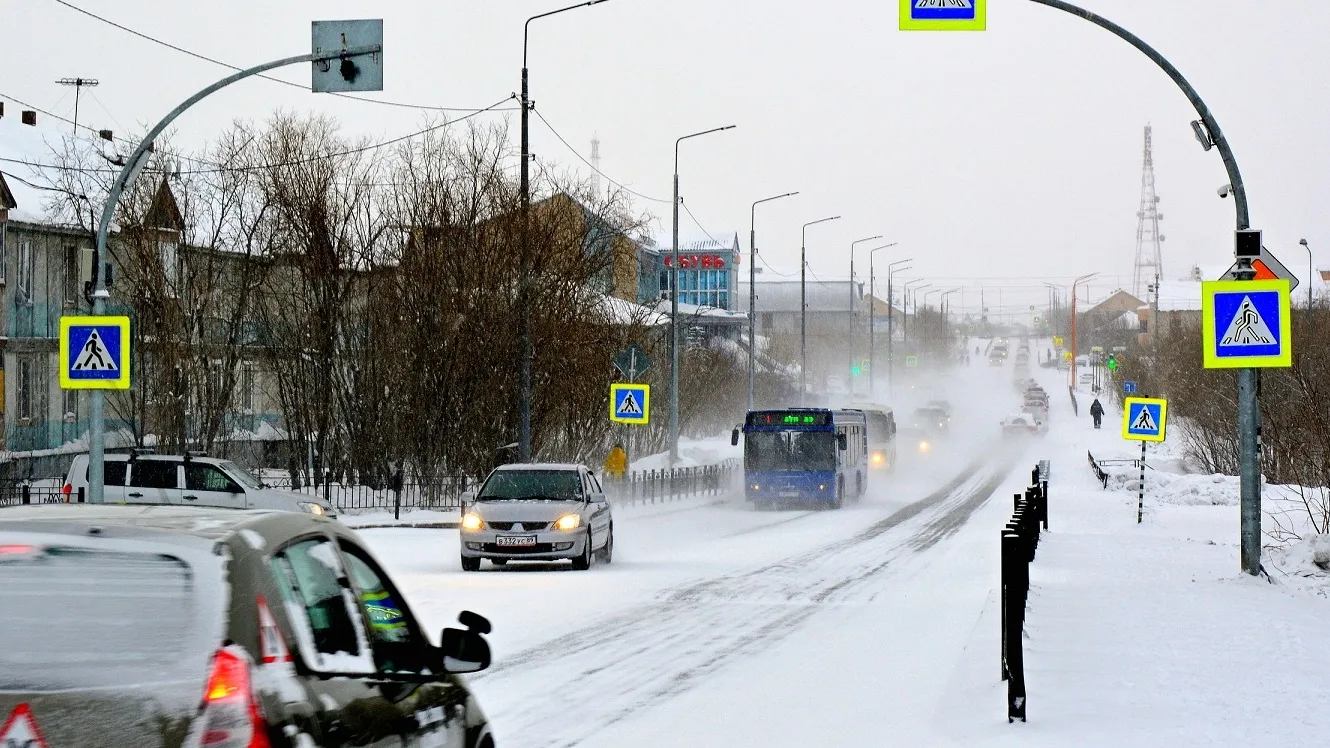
[63,453,336,518]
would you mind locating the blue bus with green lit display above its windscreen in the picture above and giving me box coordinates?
[730,407,868,508]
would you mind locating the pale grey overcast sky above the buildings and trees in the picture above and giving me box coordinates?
[0,0,1330,315]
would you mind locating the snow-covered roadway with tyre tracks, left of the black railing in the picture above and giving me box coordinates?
[364,359,1037,748]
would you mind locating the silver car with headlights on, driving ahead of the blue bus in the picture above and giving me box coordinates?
[460,463,614,571]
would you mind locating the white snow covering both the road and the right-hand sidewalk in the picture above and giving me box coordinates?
[363,346,1330,748]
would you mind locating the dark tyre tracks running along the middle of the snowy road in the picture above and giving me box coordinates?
[473,447,1011,748]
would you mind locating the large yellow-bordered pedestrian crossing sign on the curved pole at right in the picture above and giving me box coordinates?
[1201,280,1293,369]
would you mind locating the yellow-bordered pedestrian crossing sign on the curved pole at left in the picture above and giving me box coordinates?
[60,317,130,390]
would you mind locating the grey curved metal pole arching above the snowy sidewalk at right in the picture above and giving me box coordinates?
[1031,0,1255,575]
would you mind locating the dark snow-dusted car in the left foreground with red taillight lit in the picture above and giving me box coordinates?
[0,504,493,748]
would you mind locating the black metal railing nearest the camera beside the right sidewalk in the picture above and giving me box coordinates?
[1001,461,1051,723]
